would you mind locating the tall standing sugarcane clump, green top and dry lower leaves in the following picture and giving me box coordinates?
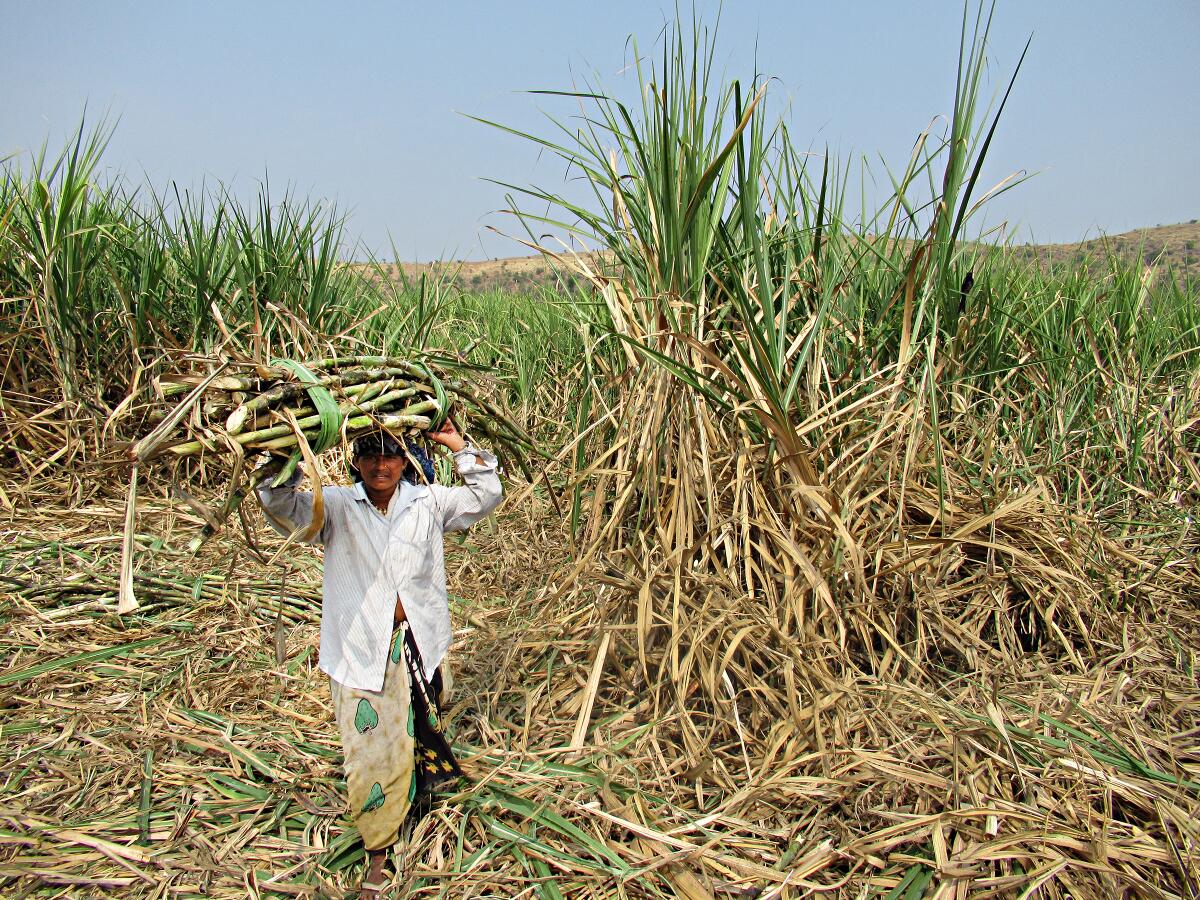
[482,4,1156,734]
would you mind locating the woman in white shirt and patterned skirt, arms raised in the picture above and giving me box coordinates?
[258,419,502,898]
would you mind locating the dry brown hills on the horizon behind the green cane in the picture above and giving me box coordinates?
[369,220,1200,292]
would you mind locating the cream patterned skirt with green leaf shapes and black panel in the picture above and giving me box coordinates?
[329,623,462,850]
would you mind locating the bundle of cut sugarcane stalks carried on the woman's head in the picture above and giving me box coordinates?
[119,356,535,613]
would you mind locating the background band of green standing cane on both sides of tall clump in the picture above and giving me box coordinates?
[0,120,1200,518]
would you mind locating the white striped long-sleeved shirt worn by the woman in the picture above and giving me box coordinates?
[258,445,502,691]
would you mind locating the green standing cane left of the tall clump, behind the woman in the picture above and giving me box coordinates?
[0,136,594,448]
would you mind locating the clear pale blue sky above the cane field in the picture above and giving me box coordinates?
[0,0,1200,260]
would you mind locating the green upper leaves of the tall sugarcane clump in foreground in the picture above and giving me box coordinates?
[489,5,1041,513]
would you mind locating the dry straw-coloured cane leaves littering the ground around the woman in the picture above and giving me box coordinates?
[7,396,1200,898]
